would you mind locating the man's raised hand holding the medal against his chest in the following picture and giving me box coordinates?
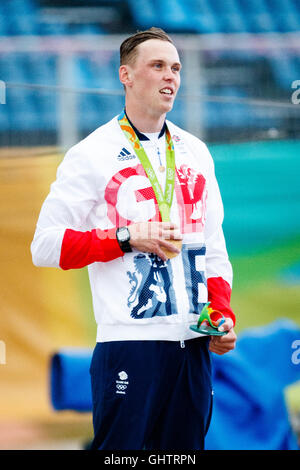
[128,222,182,261]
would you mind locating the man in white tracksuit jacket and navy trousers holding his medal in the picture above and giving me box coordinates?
[32,28,236,450]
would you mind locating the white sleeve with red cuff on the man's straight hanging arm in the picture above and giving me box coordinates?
[204,149,236,325]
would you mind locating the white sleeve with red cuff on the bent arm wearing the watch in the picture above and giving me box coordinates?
[31,145,124,269]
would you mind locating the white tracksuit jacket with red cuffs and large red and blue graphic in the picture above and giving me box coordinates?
[31,117,234,342]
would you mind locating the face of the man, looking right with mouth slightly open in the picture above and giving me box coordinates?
[126,39,181,116]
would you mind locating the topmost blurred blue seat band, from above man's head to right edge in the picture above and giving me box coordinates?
[128,0,300,34]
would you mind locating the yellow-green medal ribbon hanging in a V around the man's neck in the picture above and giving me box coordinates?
[118,111,175,222]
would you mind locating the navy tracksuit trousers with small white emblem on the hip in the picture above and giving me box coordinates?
[90,337,213,450]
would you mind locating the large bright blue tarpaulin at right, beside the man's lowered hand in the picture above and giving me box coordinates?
[206,320,300,450]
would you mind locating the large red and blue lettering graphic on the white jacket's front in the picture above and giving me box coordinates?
[105,164,206,318]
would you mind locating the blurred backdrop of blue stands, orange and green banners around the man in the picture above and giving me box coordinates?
[0,0,300,449]
